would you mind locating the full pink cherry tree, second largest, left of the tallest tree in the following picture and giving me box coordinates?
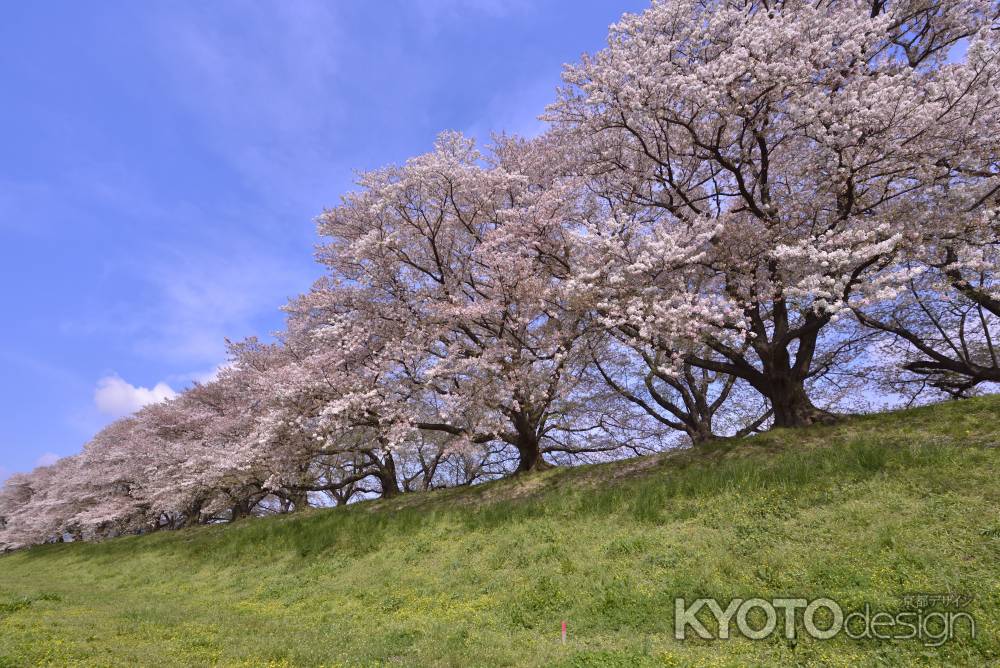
[310,133,616,471]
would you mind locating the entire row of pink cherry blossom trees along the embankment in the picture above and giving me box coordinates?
[0,0,1000,547]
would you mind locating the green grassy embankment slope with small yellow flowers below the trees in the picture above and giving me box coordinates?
[0,397,1000,666]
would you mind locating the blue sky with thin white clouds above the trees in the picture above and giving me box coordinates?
[0,0,646,479]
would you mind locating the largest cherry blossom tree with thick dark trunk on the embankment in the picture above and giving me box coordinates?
[548,0,997,426]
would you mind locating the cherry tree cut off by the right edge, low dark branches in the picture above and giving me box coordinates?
[855,3,1000,396]
